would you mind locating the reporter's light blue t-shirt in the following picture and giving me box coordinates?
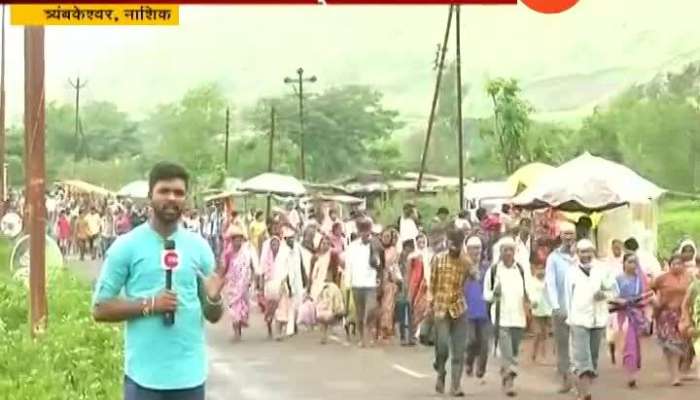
[93,223,215,390]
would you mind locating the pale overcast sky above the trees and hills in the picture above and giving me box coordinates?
[2,0,700,122]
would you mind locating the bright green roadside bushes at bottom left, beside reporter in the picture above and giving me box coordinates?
[0,271,123,400]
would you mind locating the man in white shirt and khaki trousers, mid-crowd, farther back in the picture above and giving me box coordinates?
[344,220,381,347]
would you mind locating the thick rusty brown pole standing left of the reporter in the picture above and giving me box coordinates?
[24,26,48,335]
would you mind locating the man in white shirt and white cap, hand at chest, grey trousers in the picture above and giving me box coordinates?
[565,239,614,400]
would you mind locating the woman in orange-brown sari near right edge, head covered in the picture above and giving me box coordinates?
[651,254,692,386]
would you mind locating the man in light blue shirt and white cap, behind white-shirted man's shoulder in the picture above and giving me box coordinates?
[545,222,577,393]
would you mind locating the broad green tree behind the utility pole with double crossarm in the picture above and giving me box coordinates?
[247,85,402,180]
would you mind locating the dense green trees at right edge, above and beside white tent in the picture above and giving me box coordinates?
[580,64,700,192]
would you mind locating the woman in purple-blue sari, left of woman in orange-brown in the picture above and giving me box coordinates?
[611,253,651,388]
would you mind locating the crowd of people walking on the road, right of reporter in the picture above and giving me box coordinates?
[205,198,700,399]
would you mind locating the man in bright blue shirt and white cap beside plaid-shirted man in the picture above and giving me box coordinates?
[464,236,491,382]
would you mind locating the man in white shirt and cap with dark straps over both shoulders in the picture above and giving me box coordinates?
[484,237,533,397]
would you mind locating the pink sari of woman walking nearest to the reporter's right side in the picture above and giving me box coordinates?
[223,243,253,326]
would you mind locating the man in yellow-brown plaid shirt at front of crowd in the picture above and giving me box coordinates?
[430,229,472,397]
